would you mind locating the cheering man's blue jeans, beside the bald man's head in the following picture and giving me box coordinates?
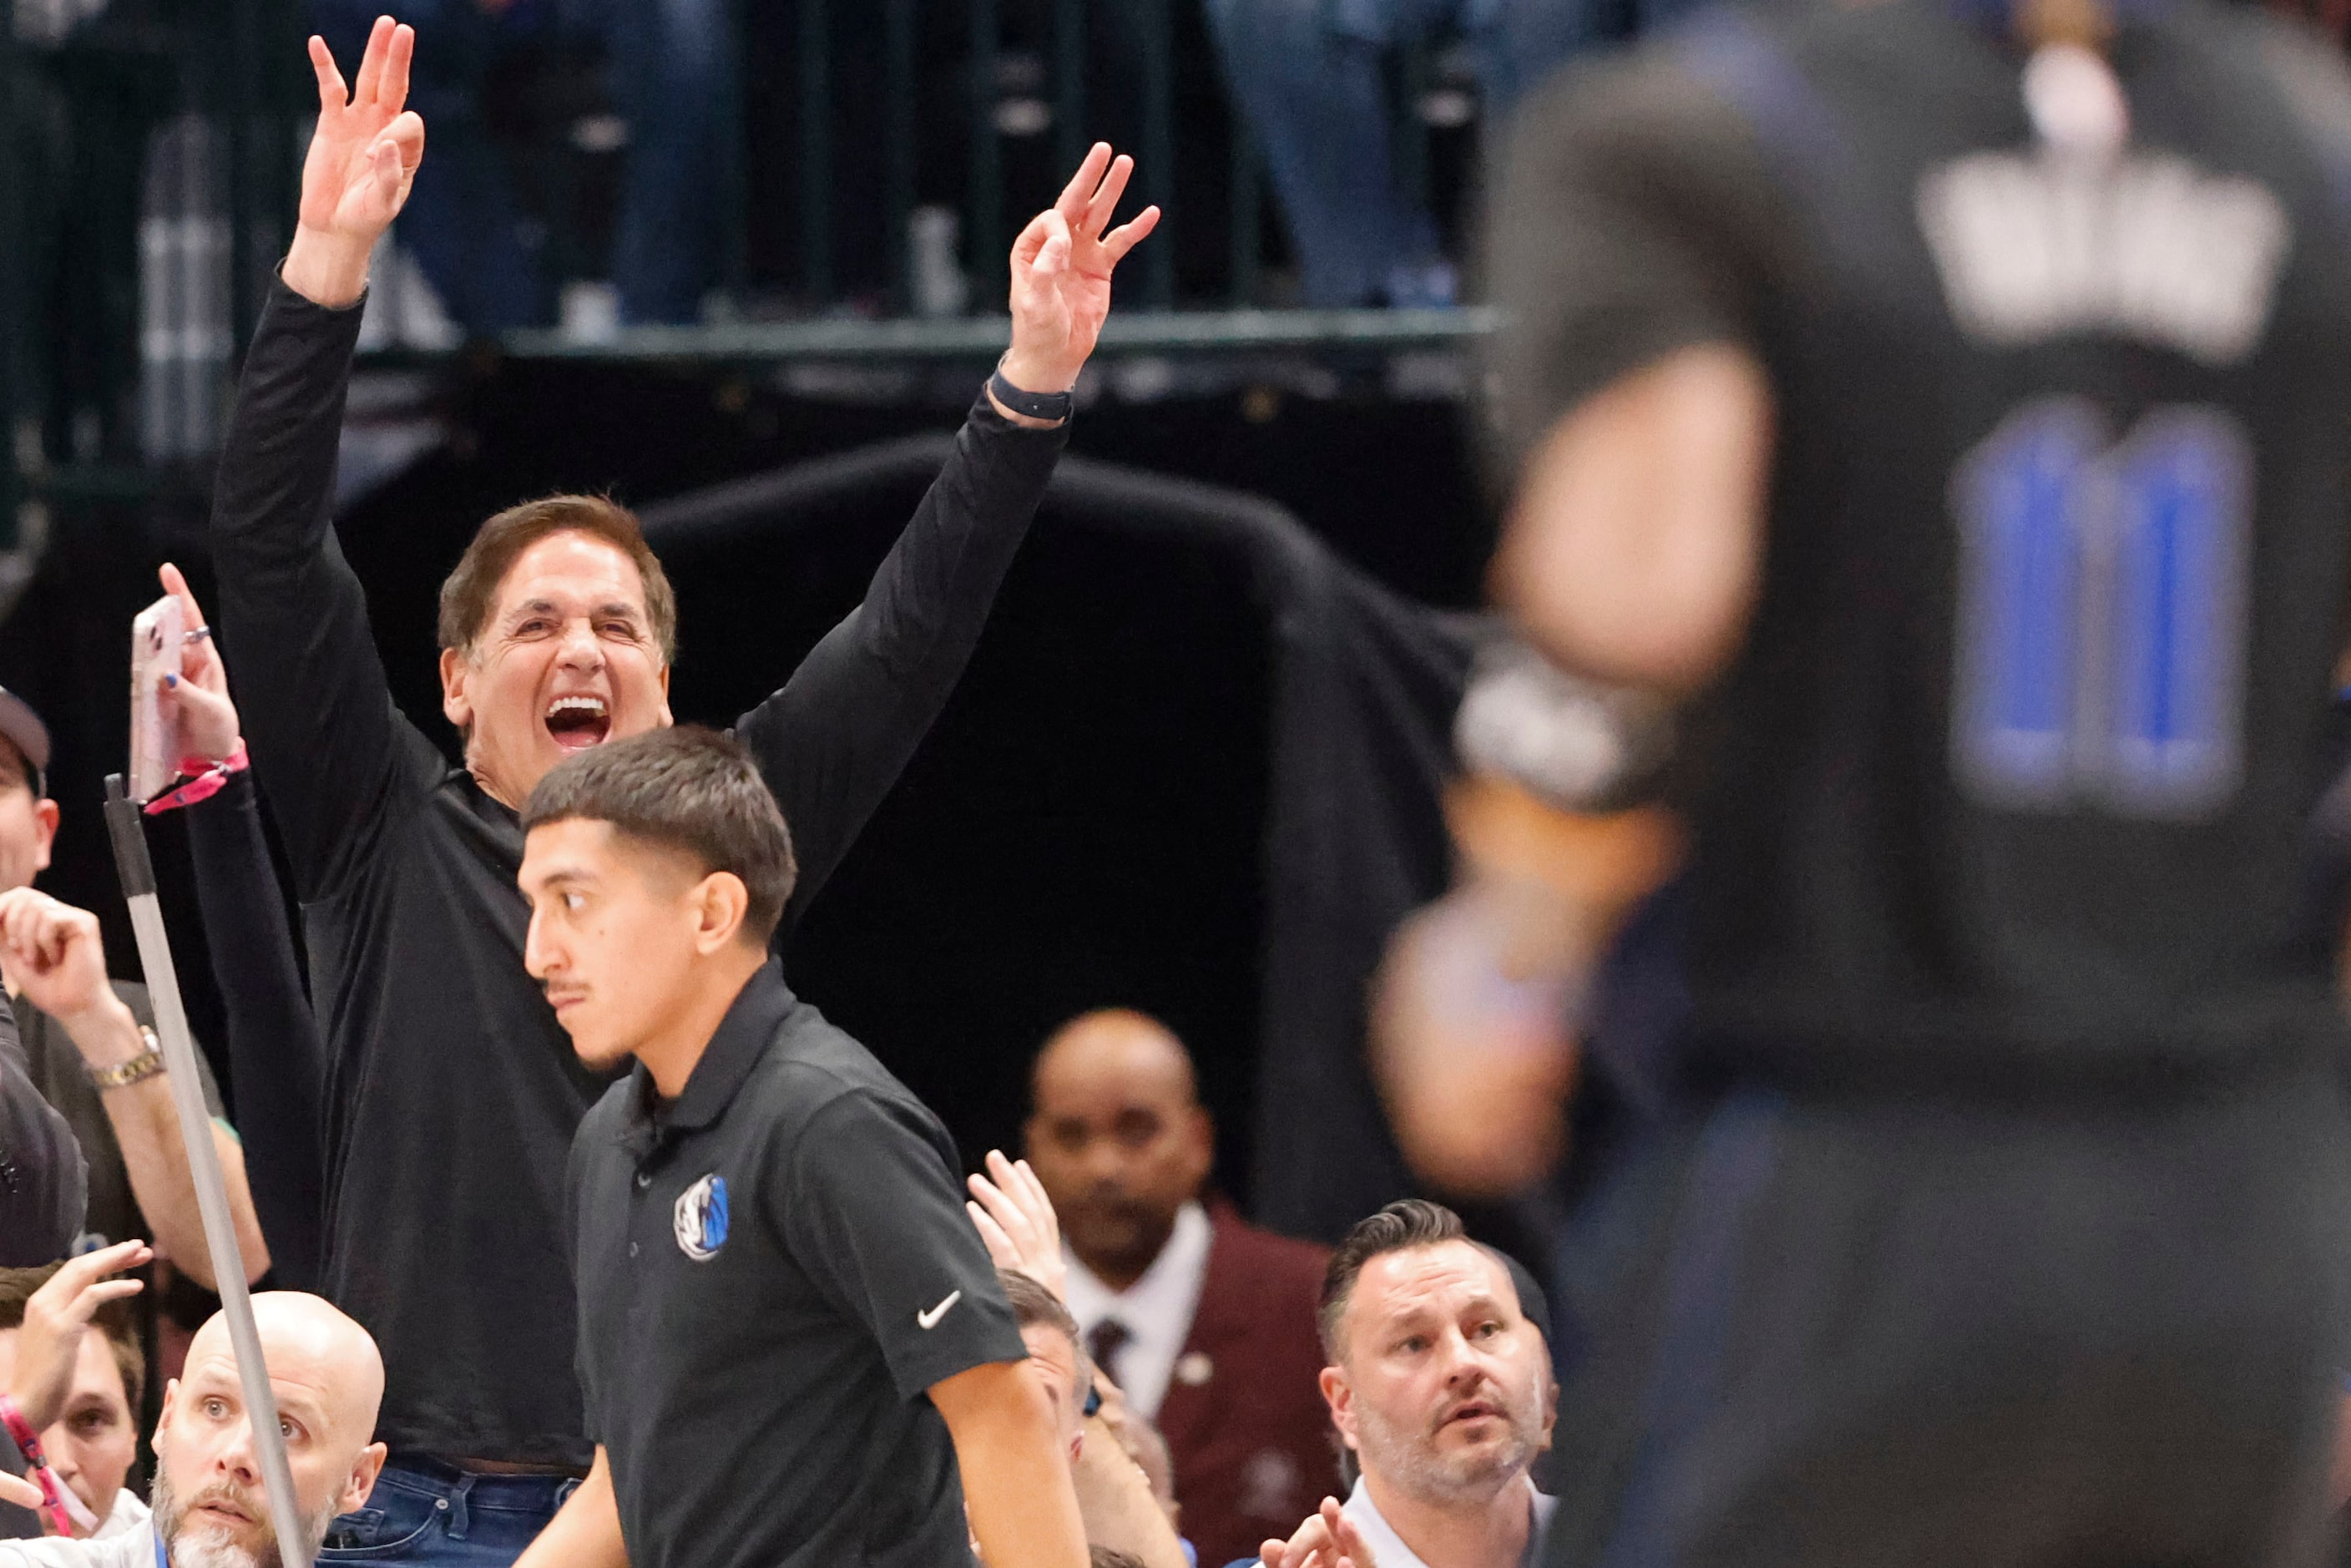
[317,1453,579,1568]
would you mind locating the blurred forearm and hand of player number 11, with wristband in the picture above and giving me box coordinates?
[1371,644,1681,1199]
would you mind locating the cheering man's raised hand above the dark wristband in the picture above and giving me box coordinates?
[1002,141,1159,408]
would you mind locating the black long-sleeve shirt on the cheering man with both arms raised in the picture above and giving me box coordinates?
[214,285,1065,1464]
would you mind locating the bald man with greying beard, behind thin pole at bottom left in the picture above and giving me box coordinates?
[0,1291,383,1568]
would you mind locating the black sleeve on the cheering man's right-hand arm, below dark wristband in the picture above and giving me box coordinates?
[736,392,1069,940]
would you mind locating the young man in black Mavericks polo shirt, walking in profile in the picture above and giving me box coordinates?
[522,729,1086,1568]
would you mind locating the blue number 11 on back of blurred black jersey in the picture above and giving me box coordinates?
[1951,397,2252,818]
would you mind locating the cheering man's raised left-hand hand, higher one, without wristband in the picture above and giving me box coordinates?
[285,17,426,308]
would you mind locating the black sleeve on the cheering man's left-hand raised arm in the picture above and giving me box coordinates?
[211,282,416,900]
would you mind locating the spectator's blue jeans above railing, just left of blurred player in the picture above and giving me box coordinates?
[1204,0,1697,308]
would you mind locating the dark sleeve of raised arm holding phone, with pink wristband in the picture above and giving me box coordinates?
[188,773,326,1291]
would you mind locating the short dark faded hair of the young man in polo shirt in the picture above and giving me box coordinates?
[522,724,799,945]
